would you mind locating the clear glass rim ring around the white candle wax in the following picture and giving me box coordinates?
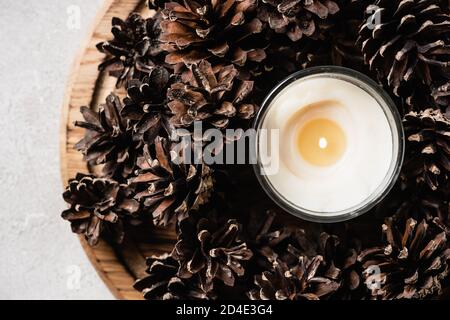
[253,66,405,223]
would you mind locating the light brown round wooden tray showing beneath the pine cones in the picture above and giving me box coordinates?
[60,0,176,299]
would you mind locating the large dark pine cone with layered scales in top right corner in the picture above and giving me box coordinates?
[358,0,450,107]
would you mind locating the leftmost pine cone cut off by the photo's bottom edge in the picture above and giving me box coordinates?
[134,254,214,300]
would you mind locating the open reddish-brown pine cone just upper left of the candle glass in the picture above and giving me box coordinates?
[168,60,257,129]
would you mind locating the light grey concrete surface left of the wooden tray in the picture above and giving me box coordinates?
[0,0,112,299]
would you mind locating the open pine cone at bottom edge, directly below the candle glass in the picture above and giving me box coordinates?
[248,246,339,300]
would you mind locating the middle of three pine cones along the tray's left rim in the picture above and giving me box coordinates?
[75,94,141,180]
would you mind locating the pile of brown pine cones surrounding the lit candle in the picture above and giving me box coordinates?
[62,0,450,300]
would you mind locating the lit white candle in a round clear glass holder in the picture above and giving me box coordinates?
[253,66,404,223]
